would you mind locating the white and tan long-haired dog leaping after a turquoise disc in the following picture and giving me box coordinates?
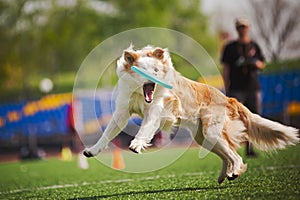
[83,46,299,183]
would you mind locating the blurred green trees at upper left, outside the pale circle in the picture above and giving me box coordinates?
[0,0,217,102]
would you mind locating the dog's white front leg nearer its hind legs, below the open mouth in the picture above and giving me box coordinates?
[129,105,163,153]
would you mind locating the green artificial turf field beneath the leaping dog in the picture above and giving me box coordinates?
[0,145,300,199]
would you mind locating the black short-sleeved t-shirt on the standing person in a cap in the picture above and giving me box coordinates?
[221,41,265,91]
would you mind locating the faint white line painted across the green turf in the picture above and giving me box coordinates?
[0,165,300,195]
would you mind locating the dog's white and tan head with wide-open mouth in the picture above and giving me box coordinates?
[117,46,173,103]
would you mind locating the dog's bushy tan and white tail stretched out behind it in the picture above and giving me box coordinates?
[230,98,300,151]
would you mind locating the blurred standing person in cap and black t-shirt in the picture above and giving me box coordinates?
[221,18,265,156]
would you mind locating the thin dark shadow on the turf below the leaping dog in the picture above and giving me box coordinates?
[69,185,231,200]
